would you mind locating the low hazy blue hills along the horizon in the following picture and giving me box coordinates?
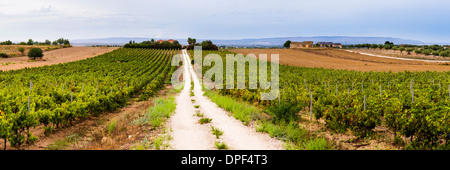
[71,36,423,47]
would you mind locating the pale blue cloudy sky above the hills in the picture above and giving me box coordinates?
[0,0,450,43]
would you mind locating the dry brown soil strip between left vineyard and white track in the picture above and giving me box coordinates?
[4,85,172,150]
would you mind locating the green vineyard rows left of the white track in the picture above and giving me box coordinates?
[0,48,179,148]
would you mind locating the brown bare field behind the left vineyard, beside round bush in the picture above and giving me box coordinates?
[0,47,118,71]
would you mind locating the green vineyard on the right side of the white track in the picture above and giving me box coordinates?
[191,51,450,149]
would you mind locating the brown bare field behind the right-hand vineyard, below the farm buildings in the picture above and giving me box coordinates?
[229,49,450,72]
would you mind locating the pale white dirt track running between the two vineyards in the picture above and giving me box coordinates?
[170,50,283,150]
